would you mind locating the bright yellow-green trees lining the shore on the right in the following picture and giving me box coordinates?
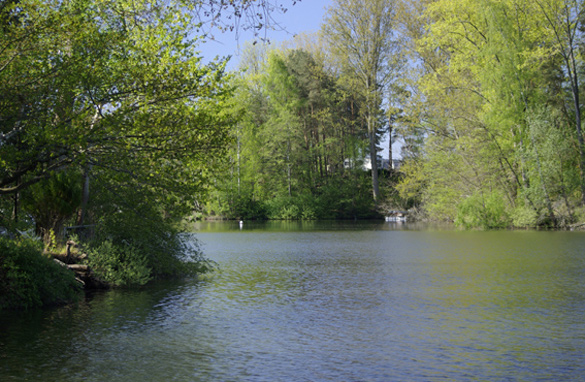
[398,0,585,228]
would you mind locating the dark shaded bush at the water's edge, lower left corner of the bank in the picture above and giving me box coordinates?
[0,237,81,310]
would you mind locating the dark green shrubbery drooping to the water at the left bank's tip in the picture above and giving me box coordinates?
[89,179,212,284]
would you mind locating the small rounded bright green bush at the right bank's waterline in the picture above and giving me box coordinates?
[455,192,510,229]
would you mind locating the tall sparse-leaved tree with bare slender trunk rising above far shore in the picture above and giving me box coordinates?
[322,0,404,200]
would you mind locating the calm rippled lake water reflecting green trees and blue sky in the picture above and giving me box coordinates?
[0,222,585,382]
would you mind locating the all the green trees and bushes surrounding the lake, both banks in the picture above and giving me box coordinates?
[0,0,585,308]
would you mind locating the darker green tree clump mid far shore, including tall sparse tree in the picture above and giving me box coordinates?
[207,0,406,219]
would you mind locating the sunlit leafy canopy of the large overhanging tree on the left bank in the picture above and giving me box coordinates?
[0,0,232,212]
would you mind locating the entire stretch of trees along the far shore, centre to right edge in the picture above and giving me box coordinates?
[210,0,585,228]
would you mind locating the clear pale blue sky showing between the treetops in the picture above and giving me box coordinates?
[200,0,333,69]
